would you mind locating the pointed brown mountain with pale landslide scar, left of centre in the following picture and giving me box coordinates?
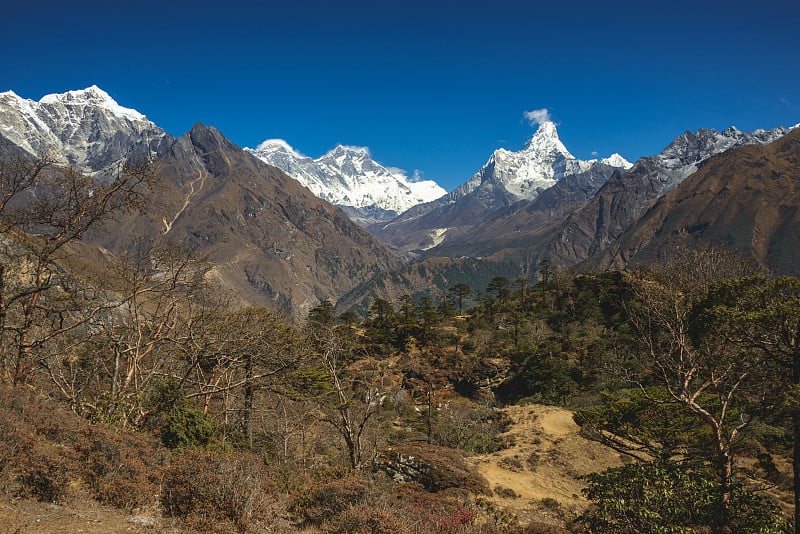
[99,124,401,317]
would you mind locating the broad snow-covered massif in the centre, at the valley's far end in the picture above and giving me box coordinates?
[245,139,447,222]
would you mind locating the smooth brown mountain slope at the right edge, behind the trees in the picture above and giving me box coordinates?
[599,129,800,275]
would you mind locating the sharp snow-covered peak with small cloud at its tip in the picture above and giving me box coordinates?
[452,122,632,200]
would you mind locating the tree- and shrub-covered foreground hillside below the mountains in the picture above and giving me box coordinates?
[0,146,800,533]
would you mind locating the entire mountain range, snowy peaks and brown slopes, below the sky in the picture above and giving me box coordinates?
[0,86,800,318]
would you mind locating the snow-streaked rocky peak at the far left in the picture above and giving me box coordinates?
[0,85,168,172]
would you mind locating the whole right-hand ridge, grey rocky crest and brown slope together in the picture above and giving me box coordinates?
[339,126,800,316]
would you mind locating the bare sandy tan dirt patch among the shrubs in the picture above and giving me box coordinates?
[471,405,623,523]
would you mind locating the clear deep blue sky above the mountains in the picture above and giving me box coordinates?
[0,0,800,190]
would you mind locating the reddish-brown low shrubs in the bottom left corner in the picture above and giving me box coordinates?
[0,388,160,509]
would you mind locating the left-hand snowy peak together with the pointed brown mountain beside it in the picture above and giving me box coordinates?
[0,87,402,318]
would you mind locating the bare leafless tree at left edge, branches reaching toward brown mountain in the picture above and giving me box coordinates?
[0,147,153,390]
